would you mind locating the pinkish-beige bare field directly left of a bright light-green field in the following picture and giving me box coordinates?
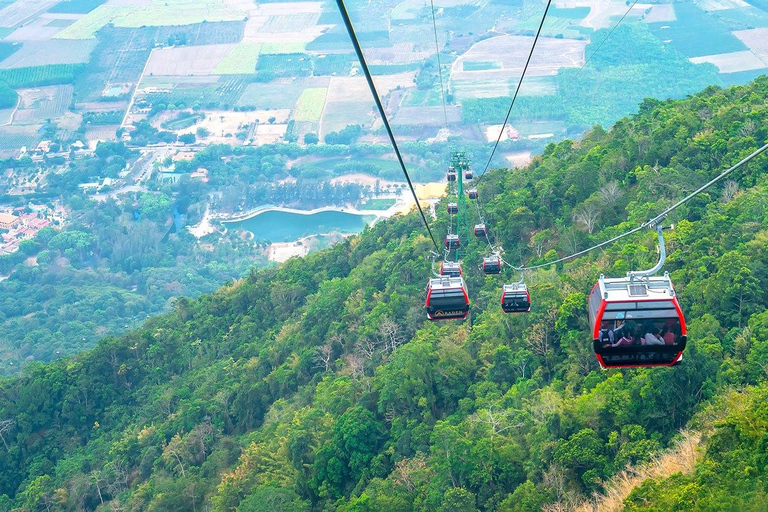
[145,44,236,76]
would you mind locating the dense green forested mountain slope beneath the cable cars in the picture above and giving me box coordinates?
[0,77,768,511]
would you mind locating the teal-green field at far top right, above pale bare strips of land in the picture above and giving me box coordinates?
[648,3,747,57]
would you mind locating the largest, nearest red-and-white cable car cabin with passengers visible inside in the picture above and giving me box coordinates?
[587,273,688,368]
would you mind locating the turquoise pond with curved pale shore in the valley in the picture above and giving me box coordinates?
[226,210,375,242]
